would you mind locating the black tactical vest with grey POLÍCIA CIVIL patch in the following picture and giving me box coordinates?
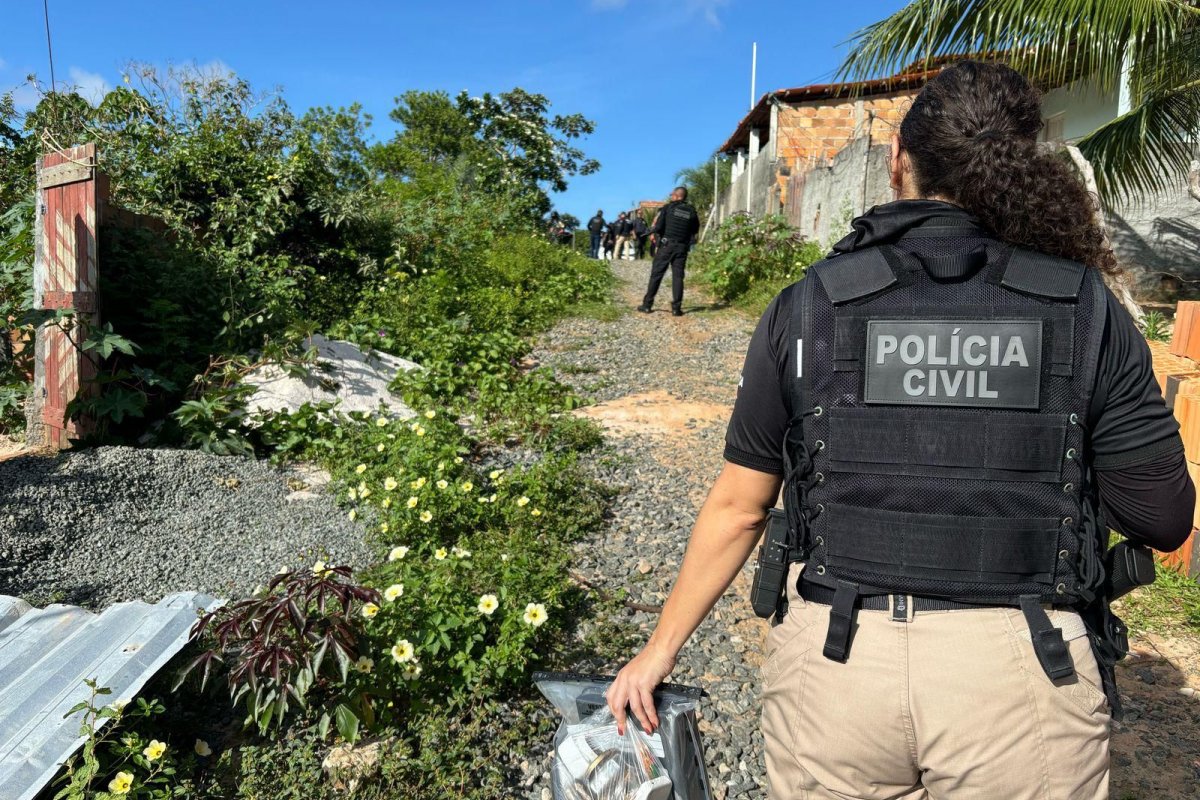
[785,231,1105,676]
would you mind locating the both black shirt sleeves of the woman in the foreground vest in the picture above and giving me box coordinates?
[725,212,1195,551]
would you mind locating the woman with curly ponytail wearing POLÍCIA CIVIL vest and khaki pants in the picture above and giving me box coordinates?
[608,61,1195,800]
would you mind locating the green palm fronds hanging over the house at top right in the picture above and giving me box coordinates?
[839,0,1200,206]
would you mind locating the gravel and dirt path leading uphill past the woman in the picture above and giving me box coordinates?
[535,261,1200,800]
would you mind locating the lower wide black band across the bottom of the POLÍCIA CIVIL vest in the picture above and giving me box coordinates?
[822,504,1060,584]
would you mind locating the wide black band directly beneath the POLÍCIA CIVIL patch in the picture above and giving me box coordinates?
[827,408,1067,482]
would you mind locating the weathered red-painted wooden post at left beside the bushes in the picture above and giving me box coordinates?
[26,144,108,449]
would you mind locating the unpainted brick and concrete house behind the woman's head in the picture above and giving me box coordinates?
[709,64,1200,300]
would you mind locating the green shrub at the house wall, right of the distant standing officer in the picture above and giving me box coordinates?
[694,215,822,305]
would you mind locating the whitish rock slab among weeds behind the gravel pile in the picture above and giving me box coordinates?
[246,335,420,420]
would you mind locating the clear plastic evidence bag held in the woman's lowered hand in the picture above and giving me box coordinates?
[533,672,713,800]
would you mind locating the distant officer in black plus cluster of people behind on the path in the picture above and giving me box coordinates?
[588,186,700,317]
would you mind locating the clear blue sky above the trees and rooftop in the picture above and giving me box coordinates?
[0,0,905,218]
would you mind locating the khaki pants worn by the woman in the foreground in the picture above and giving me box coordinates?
[762,565,1110,800]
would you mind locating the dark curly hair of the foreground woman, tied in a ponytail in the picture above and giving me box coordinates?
[900,61,1121,276]
